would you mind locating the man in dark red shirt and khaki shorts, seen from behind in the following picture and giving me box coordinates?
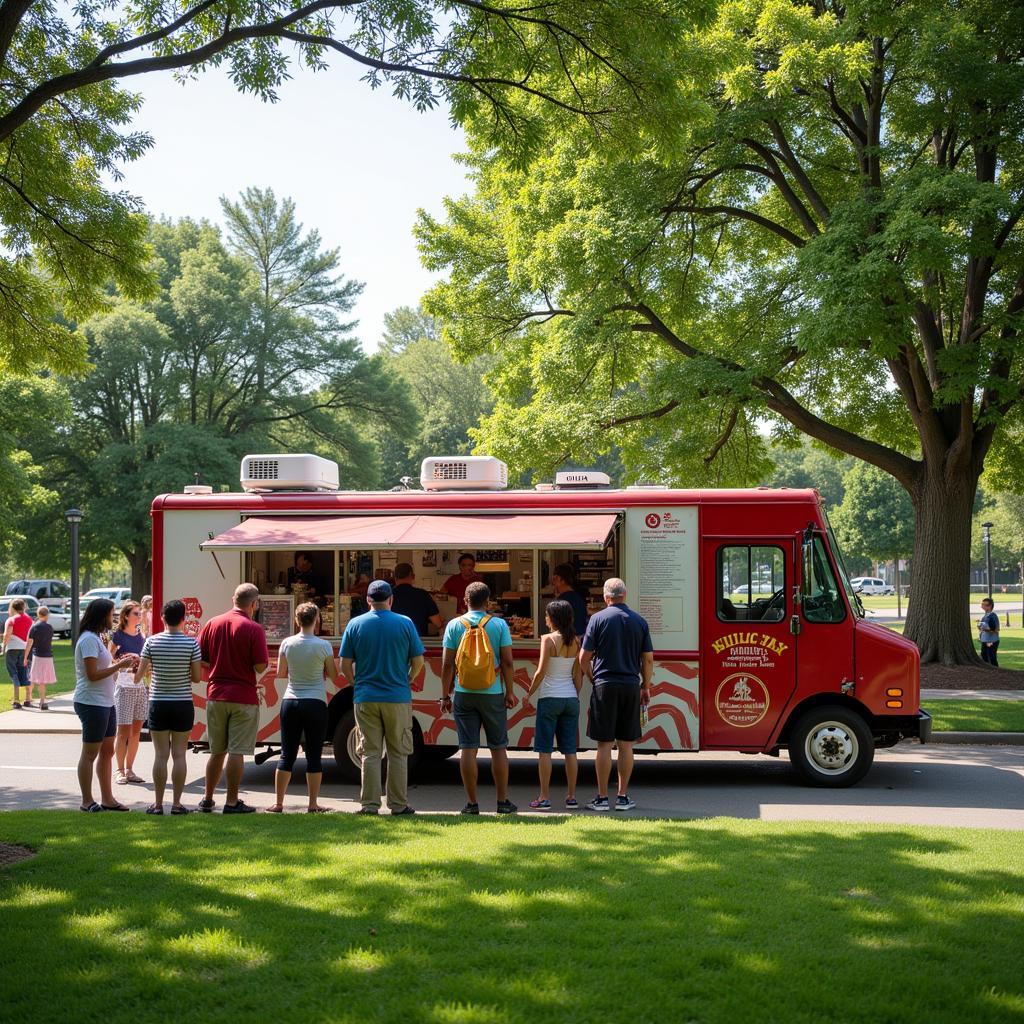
[199,583,270,814]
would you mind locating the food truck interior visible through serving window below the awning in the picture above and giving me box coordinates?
[240,540,620,643]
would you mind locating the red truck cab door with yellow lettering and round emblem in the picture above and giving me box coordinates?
[700,538,797,750]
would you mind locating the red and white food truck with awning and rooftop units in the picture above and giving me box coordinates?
[151,455,931,786]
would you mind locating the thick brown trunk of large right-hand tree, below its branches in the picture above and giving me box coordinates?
[904,462,982,666]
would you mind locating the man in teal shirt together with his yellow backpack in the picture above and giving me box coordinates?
[441,583,518,814]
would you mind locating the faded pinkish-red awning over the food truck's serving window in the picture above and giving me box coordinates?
[200,512,618,551]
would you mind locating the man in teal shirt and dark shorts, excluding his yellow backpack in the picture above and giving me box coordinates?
[441,583,517,814]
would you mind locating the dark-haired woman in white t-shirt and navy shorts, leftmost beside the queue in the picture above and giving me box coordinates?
[74,597,135,811]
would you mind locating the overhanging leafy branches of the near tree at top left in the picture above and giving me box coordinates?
[0,0,692,371]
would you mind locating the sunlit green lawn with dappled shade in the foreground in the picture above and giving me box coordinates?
[0,811,1024,1024]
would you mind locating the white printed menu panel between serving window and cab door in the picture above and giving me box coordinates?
[626,506,697,650]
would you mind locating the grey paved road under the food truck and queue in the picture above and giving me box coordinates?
[0,733,1024,829]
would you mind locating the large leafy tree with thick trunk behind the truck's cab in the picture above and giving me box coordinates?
[421,0,1024,664]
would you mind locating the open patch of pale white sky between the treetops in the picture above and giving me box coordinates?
[120,55,467,350]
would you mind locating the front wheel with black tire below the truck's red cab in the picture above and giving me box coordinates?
[788,705,874,788]
